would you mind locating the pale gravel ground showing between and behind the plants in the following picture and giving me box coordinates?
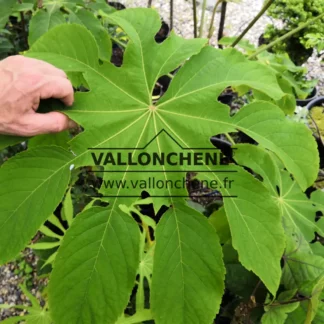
[0,0,324,321]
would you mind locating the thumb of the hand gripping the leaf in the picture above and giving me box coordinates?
[19,111,76,136]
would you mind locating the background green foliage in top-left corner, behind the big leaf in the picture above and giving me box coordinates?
[0,0,115,60]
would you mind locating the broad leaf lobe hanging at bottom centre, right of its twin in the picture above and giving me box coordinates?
[151,203,225,324]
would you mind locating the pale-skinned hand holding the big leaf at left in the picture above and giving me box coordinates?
[0,55,76,137]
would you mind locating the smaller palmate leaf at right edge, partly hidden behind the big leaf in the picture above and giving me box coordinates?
[235,144,324,289]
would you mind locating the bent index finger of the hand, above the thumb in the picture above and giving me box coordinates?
[39,76,74,106]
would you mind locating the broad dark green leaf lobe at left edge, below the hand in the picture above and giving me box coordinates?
[0,146,72,264]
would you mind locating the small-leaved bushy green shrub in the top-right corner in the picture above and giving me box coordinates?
[264,0,324,65]
